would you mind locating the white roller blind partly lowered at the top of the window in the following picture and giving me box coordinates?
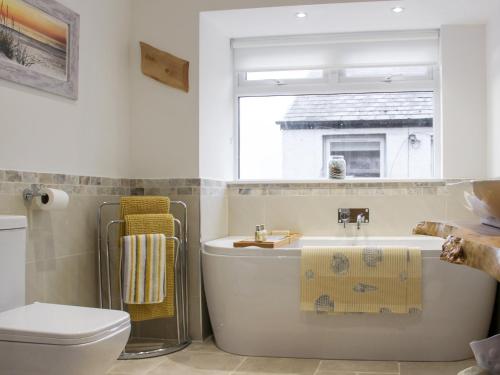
[231,30,439,72]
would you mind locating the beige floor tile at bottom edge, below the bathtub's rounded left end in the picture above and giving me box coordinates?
[165,350,245,371]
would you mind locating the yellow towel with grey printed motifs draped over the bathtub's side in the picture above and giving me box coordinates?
[300,246,422,314]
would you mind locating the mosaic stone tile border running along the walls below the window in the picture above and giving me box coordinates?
[0,170,460,200]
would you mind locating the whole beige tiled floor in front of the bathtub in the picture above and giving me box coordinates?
[108,341,475,375]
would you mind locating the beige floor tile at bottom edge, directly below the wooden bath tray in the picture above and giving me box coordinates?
[236,357,319,375]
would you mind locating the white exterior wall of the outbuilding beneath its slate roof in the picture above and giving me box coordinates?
[282,127,433,180]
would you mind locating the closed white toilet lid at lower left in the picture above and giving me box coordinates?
[0,303,130,345]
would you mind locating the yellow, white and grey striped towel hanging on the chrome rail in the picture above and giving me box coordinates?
[121,234,167,305]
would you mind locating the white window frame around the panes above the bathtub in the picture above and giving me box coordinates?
[233,63,443,181]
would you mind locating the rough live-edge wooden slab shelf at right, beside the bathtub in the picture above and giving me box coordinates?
[413,221,500,281]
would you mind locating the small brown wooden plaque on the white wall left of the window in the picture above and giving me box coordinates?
[140,42,189,92]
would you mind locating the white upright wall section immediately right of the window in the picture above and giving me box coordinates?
[441,25,487,178]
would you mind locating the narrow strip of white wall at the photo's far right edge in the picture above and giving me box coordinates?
[487,3,500,177]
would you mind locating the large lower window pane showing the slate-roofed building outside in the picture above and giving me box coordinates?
[238,91,435,179]
